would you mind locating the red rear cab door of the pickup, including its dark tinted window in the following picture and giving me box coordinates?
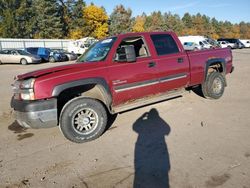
[151,33,190,93]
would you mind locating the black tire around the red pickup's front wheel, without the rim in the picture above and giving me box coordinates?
[59,98,107,143]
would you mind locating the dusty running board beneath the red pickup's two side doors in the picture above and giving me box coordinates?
[112,89,186,114]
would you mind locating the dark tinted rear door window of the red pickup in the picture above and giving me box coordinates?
[151,34,179,55]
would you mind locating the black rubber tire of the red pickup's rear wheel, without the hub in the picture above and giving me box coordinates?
[203,72,225,99]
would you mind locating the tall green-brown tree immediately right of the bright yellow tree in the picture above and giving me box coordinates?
[109,5,132,35]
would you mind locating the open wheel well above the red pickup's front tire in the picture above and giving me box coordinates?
[57,84,111,122]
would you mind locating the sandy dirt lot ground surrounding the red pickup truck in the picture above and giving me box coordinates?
[0,49,250,188]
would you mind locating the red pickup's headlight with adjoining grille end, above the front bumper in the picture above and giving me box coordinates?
[12,78,35,100]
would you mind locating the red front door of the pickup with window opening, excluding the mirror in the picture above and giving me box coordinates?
[108,36,158,106]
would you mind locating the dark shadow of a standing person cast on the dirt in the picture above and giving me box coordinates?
[133,108,170,188]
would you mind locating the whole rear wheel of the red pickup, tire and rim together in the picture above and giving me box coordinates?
[201,72,226,99]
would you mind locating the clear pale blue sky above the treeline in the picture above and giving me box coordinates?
[86,0,250,23]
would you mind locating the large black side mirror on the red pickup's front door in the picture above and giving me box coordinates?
[115,45,136,62]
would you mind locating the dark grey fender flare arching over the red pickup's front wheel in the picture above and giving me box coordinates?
[52,78,112,107]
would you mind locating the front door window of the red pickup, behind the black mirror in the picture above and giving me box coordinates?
[116,36,149,58]
